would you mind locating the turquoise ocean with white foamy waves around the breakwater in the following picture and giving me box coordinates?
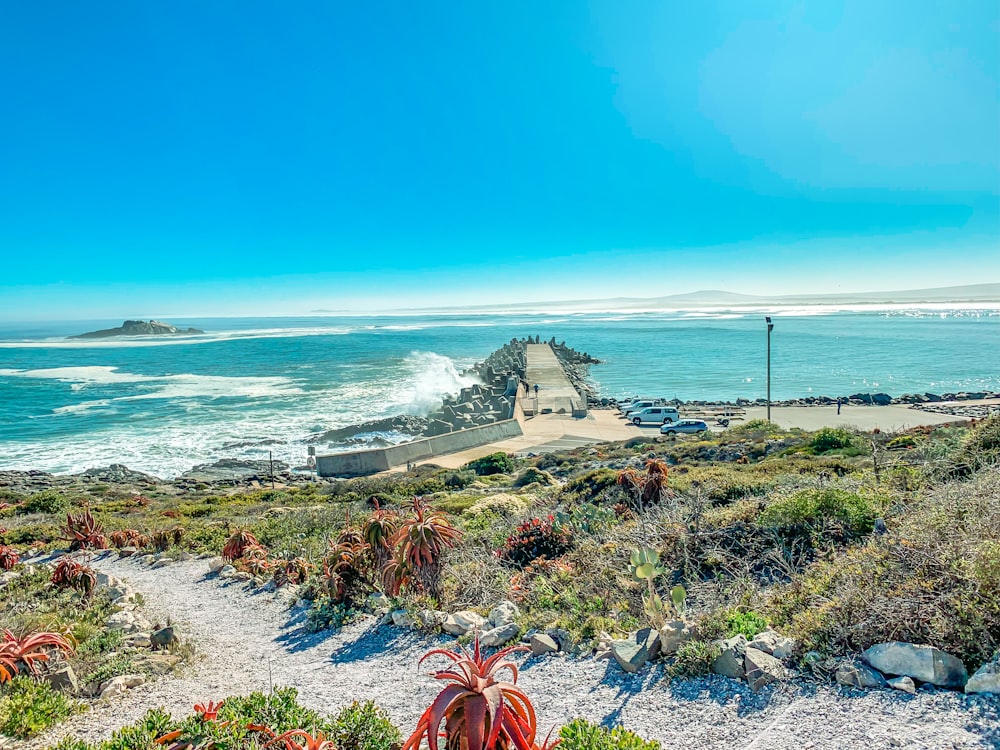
[0,305,1000,477]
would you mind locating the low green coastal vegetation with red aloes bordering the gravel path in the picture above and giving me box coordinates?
[0,418,1000,750]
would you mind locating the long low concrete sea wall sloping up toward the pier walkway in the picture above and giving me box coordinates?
[316,408,522,477]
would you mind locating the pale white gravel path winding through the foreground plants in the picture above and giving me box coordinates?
[29,558,1000,750]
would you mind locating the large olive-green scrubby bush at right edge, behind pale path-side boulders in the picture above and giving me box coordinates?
[765,469,1000,668]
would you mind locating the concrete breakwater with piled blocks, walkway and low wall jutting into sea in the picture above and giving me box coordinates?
[314,337,596,476]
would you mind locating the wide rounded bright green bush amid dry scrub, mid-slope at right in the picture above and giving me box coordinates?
[757,487,879,536]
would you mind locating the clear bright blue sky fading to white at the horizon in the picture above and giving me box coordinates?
[0,0,1000,320]
